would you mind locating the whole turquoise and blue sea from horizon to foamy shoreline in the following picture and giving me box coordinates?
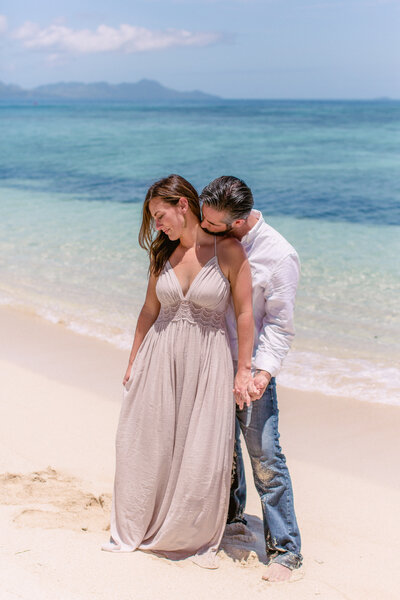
[0,101,400,404]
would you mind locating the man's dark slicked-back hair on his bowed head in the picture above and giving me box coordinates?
[200,175,254,221]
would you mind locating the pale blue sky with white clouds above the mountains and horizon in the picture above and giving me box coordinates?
[0,0,400,98]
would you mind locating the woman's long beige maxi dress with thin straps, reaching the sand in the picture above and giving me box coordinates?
[103,239,235,568]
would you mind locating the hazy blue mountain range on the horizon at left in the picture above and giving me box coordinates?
[0,79,219,102]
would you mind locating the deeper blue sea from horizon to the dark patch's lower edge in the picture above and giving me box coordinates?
[0,101,400,225]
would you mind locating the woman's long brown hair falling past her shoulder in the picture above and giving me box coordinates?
[139,175,201,276]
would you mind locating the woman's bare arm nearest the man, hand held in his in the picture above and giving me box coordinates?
[220,238,254,408]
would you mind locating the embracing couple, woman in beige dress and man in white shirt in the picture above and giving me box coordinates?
[103,175,301,581]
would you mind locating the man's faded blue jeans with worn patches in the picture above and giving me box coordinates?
[228,378,302,569]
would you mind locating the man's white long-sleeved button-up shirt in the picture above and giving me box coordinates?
[226,211,300,377]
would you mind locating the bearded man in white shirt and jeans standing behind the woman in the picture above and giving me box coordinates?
[200,177,302,581]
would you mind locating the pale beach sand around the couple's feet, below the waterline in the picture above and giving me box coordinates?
[0,307,400,600]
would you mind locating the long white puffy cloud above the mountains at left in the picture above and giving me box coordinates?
[12,21,222,54]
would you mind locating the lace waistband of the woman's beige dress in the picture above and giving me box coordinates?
[154,300,225,330]
